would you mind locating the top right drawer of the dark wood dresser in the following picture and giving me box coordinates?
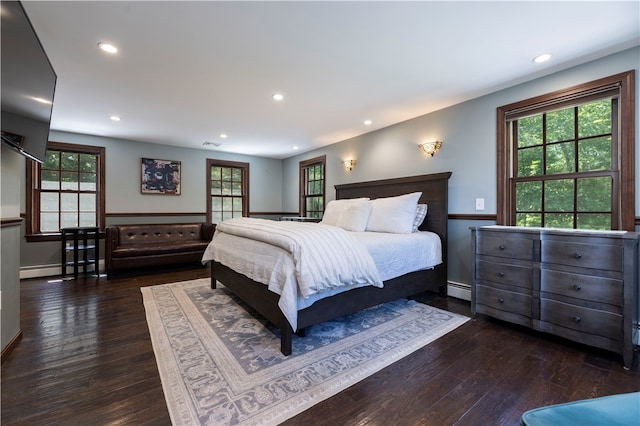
[540,240,622,271]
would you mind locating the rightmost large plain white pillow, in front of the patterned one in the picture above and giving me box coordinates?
[366,192,422,234]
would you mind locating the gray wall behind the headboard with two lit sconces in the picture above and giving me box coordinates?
[283,47,640,284]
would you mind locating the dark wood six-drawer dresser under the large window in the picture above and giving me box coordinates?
[471,226,638,368]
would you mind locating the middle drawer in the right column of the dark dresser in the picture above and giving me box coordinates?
[540,269,623,307]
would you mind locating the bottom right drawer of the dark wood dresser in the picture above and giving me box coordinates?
[540,298,622,340]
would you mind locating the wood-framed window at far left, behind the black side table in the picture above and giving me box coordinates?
[27,142,105,240]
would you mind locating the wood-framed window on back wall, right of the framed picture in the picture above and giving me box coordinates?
[207,159,249,223]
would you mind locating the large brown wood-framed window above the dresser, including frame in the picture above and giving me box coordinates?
[498,72,635,231]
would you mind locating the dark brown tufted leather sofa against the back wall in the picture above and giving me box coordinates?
[105,223,215,279]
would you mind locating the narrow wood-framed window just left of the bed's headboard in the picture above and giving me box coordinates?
[300,155,326,219]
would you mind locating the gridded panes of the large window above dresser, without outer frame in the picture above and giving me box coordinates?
[511,98,617,230]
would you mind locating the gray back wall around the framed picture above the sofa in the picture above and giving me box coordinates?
[20,131,282,270]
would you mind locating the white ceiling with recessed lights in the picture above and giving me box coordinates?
[23,0,640,158]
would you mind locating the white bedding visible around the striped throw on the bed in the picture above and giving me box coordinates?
[202,218,442,330]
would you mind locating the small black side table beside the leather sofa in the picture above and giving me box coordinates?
[60,227,100,279]
